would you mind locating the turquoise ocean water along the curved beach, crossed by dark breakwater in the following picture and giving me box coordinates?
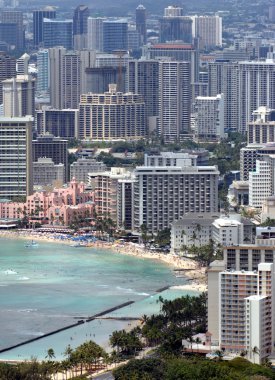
[0,239,198,360]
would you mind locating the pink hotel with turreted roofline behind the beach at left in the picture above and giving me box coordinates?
[0,178,94,225]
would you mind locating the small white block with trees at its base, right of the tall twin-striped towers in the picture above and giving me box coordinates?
[195,94,224,142]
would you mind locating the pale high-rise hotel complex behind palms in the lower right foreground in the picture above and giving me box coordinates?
[208,239,275,363]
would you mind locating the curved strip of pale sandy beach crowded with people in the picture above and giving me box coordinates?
[0,230,207,292]
